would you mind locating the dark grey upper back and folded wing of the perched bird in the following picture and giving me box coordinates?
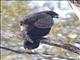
[26,12,53,28]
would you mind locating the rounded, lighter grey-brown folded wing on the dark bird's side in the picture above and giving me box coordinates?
[34,13,53,28]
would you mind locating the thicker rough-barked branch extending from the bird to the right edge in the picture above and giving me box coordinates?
[42,41,80,54]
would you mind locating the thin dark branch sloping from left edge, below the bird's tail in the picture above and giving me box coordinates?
[0,42,75,60]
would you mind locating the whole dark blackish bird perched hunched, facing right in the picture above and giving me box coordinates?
[20,11,59,49]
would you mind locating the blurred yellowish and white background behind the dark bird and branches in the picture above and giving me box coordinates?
[0,0,80,60]
